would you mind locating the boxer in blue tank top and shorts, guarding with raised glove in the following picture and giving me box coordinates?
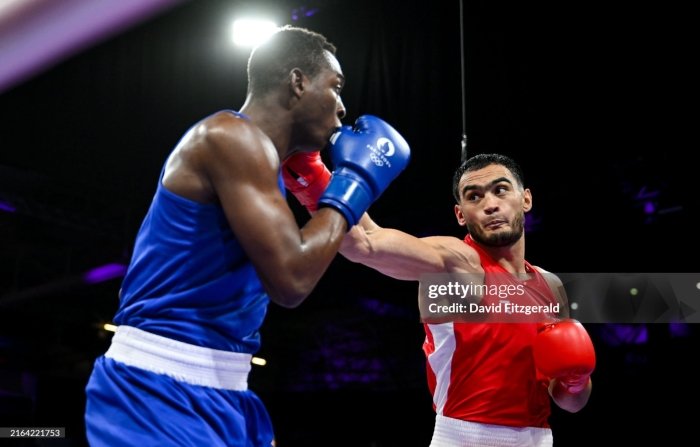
[85,27,410,447]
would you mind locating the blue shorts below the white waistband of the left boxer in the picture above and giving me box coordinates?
[85,356,274,447]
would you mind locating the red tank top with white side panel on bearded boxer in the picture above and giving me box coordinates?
[423,235,557,427]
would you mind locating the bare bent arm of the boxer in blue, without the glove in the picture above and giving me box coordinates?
[204,120,347,307]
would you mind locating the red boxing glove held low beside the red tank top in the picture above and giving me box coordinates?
[533,319,595,393]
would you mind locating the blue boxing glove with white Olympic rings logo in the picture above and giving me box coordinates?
[319,115,411,230]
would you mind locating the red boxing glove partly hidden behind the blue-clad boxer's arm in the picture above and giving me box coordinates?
[282,152,331,213]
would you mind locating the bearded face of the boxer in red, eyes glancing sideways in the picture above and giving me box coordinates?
[455,165,532,247]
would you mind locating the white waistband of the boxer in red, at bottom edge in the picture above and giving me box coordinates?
[430,415,553,447]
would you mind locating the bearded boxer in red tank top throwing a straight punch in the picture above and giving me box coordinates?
[283,154,595,447]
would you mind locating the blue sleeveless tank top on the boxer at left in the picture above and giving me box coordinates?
[114,111,285,354]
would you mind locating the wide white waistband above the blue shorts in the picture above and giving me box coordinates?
[105,326,252,391]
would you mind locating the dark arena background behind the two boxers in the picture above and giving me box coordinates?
[0,0,700,447]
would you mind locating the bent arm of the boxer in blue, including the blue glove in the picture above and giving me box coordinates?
[200,116,410,307]
